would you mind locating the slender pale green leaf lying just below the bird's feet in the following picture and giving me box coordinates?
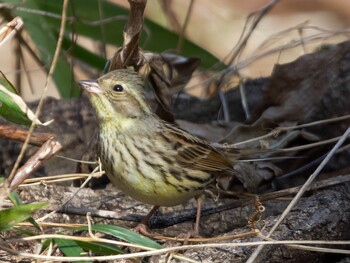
[76,225,163,249]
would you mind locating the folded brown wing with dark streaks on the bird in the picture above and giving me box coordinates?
[162,123,233,172]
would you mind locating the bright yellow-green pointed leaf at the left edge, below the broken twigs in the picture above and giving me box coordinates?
[0,202,49,232]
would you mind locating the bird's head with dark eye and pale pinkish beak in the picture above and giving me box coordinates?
[79,69,151,122]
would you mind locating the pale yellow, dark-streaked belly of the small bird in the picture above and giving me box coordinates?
[100,135,210,206]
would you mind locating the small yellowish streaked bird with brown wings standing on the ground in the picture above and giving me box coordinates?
[79,69,238,234]
